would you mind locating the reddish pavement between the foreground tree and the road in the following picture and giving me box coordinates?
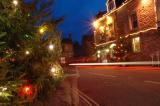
[33,66,79,106]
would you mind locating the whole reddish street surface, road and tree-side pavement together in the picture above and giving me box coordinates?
[34,66,160,106]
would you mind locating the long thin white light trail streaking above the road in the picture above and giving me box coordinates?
[69,61,160,66]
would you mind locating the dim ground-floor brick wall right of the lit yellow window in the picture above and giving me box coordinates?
[129,30,160,61]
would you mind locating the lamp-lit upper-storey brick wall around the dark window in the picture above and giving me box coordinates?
[111,0,156,36]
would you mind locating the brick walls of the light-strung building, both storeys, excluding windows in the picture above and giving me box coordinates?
[95,0,160,61]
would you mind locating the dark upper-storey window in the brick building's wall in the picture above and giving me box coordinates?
[130,13,138,30]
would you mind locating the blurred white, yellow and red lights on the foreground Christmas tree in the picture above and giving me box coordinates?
[0,0,60,97]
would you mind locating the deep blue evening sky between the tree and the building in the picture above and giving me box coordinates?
[53,0,106,42]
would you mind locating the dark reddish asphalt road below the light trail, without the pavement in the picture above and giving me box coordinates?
[77,66,160,106]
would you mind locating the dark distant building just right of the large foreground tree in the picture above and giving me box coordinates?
[62,35,74,63]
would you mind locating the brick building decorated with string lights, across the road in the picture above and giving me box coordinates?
[93,0,160,61]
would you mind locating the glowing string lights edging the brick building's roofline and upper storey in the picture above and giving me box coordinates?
[92,0,158,47]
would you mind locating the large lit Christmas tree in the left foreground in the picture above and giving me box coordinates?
[0,0,63,106]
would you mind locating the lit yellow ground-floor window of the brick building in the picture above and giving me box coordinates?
[132,37,141,53]
